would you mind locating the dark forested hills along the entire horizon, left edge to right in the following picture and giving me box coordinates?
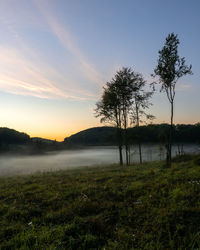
[0,123,200,154]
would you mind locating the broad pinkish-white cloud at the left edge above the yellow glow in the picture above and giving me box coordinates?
[0,47,95,100]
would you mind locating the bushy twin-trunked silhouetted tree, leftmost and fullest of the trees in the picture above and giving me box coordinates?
[95,68,135,165]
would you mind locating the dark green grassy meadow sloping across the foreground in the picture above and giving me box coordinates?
[0,156,200,250]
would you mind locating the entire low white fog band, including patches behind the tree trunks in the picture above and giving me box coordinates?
[0,144,199,176]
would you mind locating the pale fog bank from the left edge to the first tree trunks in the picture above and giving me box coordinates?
[0,147,118,176]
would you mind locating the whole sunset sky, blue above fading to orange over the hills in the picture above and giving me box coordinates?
[0,0,200,141]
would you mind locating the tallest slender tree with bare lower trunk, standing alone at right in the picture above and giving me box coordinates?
[153,33,192,166]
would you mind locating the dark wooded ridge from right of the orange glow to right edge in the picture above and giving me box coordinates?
[64,123,200,146]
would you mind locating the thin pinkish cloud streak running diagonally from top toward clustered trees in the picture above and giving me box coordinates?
[34,0,104,87]
